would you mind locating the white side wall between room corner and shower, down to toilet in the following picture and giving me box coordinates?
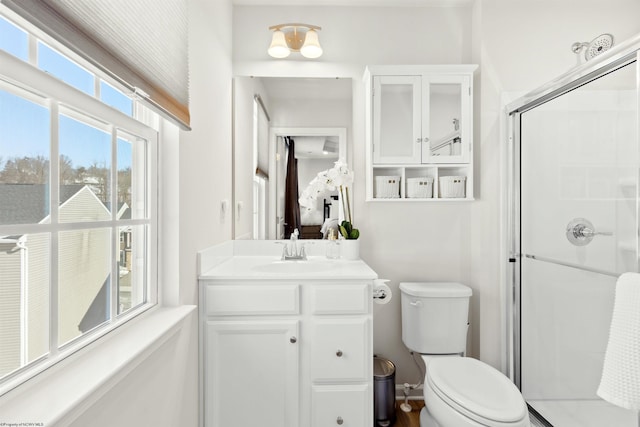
[469,0,640,376]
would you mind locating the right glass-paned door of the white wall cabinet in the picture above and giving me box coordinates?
[422,75,472,163]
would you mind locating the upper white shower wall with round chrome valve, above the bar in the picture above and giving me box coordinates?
[522,89,638,273]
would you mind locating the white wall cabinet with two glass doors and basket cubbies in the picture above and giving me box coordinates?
[364,65,477,201]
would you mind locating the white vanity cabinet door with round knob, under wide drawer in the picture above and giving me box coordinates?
[204,320,299,427]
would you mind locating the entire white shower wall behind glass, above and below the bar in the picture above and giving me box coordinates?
[521,61,638,420]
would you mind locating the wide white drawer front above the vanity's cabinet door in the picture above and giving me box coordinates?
[205,284,300,316]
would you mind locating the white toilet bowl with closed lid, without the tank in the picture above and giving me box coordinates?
[420,357,530,427]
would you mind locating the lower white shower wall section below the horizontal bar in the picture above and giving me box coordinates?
[522,259,616,400]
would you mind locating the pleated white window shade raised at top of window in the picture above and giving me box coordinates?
[0,0,189,129]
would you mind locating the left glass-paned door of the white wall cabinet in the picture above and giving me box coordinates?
[373,76,422,164]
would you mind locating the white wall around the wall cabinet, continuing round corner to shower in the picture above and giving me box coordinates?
[233,0,640,390]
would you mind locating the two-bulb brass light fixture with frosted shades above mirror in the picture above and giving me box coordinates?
[267,24,322,59]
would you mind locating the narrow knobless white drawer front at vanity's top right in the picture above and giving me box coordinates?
[310,283,372,314]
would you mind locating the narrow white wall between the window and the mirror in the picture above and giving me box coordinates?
[180,0,232,304]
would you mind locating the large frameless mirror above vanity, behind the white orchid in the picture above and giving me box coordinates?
[233,76,353,239]
